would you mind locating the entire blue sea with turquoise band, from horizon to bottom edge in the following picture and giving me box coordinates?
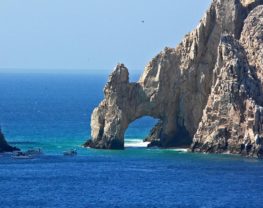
[0,74,263,208]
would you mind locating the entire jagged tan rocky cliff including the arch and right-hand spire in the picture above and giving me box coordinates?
[86,0,263,157]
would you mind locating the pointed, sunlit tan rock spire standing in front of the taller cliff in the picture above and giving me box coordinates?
[192,36,262,153]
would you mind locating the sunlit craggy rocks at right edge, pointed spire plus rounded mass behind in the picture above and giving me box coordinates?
[192,6,263,155]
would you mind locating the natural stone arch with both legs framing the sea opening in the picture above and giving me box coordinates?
[86,64,195,149]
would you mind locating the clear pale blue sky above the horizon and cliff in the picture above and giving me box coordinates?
[0,0,211,72]
